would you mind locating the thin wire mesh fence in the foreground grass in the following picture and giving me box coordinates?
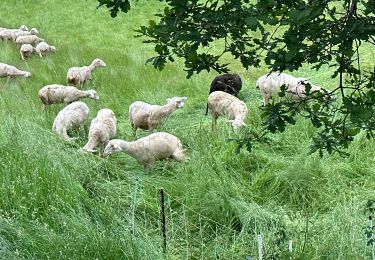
[93,159,375,260]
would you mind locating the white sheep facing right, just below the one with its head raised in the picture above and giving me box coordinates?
[38,84,99,110]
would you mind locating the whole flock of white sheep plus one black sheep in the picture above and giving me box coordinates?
[0,25,322,170]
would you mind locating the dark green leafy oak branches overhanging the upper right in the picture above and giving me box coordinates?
[98,0,375,155]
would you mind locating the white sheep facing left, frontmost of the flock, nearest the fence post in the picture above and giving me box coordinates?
[103,132,186,171]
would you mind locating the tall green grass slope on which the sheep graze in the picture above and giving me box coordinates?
[0,0,375,259]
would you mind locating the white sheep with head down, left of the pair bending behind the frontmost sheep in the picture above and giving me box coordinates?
[52,101,90,141]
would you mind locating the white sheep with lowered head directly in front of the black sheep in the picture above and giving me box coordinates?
[208,91,248,133]
